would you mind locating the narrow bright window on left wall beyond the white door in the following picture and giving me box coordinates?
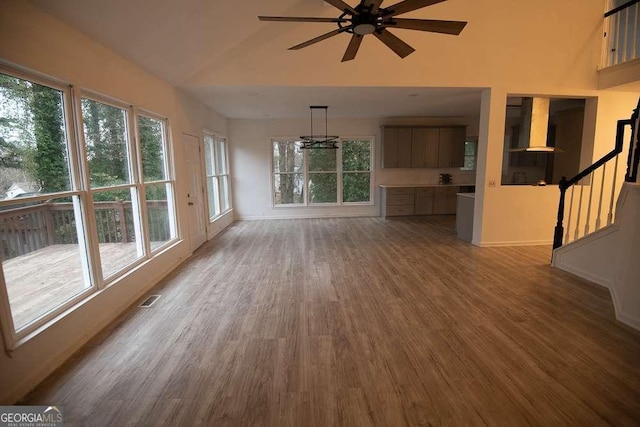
[204,132,231,220]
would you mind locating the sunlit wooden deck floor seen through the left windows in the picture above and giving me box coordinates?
[3,242,164,328]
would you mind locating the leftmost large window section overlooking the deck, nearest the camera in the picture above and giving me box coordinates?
[0,74,93,337]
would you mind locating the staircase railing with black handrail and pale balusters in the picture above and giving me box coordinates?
[553,99,640,249]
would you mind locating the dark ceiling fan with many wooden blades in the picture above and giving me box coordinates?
[258,0,467,62]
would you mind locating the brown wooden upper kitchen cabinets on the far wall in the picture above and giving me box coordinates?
[382,126,466,168]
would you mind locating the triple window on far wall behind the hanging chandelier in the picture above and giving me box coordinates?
[272,138,373,206]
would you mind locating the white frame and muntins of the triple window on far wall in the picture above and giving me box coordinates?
[269,136,375,209]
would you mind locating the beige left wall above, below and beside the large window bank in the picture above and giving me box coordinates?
[0,1,227,404]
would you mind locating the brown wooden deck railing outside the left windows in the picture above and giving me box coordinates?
[0,200,170,260]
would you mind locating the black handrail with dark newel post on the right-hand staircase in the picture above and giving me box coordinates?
[553,98,640,249]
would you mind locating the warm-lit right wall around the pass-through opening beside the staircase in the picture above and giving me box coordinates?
[473,86,639,246]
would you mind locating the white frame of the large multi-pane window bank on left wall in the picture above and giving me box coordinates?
[0,64,180,352]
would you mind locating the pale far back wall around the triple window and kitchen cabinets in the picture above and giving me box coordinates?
[229,117,478,219]
